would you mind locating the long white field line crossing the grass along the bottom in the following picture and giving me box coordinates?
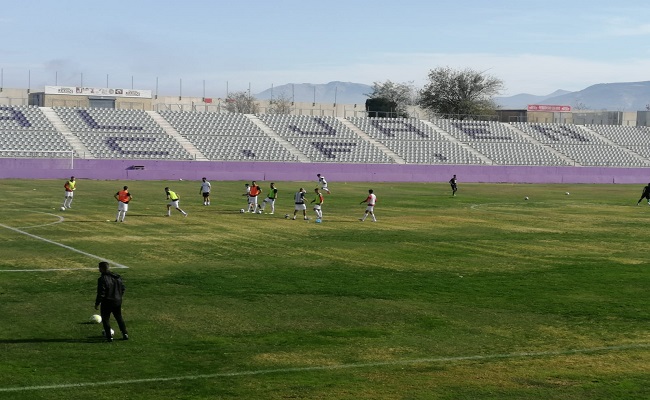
[0,343,650,393]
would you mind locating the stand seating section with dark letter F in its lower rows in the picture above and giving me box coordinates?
[257,114,395,164]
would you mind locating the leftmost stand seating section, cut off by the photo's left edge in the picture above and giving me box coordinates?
[0,106,73,158]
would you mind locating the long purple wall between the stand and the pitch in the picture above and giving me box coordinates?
[0,158,650,184]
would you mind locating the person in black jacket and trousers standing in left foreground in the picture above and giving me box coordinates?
[95,261,129,342]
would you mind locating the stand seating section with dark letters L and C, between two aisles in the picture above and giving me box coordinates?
[54,107,191,160]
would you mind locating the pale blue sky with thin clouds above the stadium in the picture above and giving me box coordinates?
[0,0,650,98]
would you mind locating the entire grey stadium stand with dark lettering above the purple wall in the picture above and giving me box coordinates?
[0,105,650,167]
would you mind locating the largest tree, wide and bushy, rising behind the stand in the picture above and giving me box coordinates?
[419,67,504,119]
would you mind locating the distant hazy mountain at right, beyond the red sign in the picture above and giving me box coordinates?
[495,81,650,111]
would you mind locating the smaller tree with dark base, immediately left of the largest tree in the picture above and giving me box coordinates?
[366,80,417,118]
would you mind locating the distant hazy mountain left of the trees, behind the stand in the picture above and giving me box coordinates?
[255,81,372,104]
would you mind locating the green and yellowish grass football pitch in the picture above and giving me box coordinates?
[0,180,650,399]
